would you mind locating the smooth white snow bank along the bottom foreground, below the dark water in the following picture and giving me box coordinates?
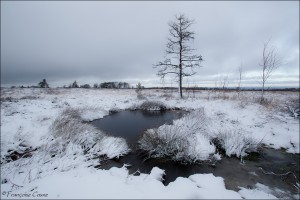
[1,167,256,199]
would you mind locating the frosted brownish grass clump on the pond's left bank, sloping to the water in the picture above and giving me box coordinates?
[44,108,129,158]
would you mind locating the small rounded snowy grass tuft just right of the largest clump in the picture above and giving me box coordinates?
[214,130,261,158]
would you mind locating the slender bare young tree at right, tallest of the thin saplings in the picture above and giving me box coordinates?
[260,40,281,101]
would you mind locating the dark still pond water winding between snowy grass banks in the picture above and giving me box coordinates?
[92,111,300,197]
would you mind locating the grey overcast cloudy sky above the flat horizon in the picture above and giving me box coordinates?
[1,1,299,86]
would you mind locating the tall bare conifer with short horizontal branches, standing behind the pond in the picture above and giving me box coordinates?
[155,14,202,98]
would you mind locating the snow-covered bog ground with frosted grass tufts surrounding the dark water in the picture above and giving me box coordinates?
[1,88,300,199]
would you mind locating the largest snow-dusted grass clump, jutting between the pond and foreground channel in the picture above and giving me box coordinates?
[138,109,215,163]
